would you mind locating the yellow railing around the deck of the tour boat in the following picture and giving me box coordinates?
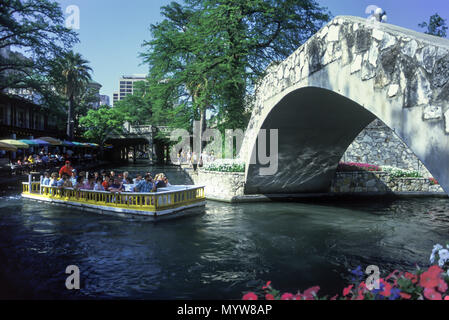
[22,182,205,211]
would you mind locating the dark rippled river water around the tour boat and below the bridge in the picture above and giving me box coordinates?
[0,165,449,299]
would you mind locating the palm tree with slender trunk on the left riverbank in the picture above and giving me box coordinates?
[54,51,92,139]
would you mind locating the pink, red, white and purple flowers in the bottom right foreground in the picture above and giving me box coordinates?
[243,244,449,300]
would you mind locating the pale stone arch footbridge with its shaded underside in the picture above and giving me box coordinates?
[240,16,449,194]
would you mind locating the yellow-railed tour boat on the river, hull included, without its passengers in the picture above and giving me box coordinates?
[22,175,206,220]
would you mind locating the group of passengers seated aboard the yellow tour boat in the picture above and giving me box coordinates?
[42,161,171,193]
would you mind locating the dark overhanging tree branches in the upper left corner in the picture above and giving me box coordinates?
[0,0,78,93]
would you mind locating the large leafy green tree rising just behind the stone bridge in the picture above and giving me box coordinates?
[141,0,330,151]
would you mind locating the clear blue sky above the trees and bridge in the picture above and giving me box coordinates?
[54,0,449,99]
